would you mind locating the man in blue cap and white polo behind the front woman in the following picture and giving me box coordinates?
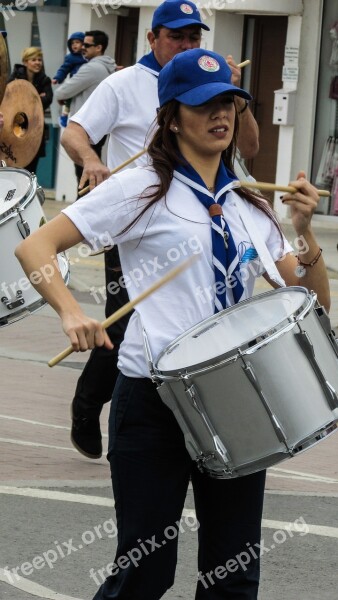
[61,0,259,458]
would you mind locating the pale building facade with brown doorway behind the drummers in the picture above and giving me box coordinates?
[1,0,338,222]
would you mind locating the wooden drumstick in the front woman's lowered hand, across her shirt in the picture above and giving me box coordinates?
[48,255,198,367]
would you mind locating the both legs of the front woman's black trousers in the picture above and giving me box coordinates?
[94,374,265,600]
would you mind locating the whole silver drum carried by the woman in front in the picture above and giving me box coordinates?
[154,287,338,479]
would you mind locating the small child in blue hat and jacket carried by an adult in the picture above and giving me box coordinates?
[52,31,87,127]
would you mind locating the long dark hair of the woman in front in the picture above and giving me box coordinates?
[120,100,282,236]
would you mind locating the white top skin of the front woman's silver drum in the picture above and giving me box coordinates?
[156,287,312,374]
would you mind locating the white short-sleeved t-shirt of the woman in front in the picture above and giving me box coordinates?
[63,167,292,377]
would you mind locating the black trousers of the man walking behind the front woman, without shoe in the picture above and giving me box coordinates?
[73,247,130,418]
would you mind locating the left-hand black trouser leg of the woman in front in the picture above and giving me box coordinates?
[95,375,191,600]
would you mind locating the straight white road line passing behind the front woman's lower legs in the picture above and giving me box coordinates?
[0,486,338,538]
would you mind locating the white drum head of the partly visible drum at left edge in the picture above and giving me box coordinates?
[0,167,34,217]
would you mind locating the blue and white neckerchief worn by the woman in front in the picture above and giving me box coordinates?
[174,161,244,312]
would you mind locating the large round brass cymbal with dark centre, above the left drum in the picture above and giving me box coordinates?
[0,79,44,168]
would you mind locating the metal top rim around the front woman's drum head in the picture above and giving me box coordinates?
[154,286,316,381]
